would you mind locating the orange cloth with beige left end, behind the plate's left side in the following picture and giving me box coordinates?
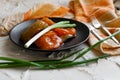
[0,3,69,36]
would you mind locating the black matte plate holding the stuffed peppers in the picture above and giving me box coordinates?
[9,18,90,51]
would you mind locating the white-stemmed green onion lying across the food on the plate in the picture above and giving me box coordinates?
[24,21,76,48]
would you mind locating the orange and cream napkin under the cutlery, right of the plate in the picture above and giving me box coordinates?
[71,0,120,55]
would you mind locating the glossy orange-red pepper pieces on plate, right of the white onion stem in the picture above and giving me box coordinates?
[35,28,76,50]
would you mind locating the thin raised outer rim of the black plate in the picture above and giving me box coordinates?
[9,17,90,52]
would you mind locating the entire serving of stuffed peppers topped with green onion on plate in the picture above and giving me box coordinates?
[21,18,76,50]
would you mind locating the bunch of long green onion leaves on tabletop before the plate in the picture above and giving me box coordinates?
[0,31,120,69]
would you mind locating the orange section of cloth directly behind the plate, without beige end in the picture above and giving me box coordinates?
[24,4,69,20]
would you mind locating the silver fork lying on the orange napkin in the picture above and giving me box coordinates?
[91,17,120,45]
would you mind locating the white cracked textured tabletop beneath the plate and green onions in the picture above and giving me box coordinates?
[0,0,120,80]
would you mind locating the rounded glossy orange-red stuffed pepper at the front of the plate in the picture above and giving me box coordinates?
[35,31,63,50]
